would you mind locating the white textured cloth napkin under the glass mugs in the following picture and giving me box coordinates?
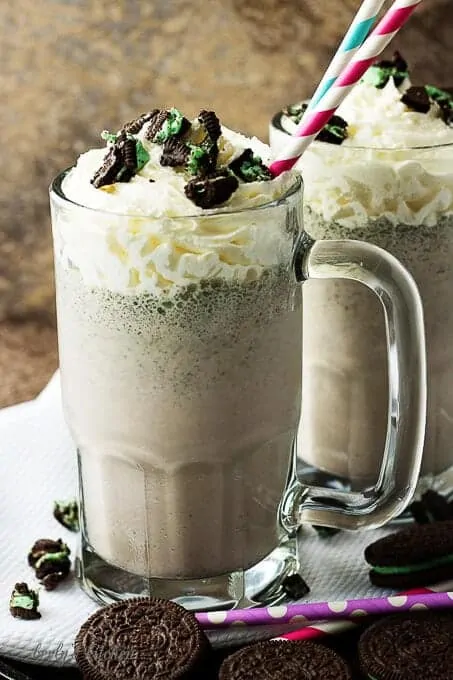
[0,373,391,666]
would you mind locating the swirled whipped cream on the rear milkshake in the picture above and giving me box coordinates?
[271,78,453,228]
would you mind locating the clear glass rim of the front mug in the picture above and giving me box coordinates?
[49,166,303,216]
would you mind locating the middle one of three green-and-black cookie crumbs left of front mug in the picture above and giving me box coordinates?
[28,538,71,590]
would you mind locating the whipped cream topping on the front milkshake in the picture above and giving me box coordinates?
[54,125,294,295]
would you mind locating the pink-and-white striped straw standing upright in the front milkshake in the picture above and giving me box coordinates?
[269,0,422,177]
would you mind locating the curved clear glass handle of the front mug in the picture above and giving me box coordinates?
[280,233,426,533]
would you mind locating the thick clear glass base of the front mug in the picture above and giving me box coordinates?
[75,533,299,611]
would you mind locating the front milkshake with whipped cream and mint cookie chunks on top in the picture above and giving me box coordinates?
[53,109,302,579]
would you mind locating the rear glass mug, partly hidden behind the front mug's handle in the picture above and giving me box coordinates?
[270,113,453,495]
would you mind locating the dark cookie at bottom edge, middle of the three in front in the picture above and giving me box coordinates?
[219,640,352,680]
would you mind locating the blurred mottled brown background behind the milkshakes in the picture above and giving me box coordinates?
[0,0,453,406]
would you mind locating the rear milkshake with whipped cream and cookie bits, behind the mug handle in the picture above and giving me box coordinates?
[271,54,453,487]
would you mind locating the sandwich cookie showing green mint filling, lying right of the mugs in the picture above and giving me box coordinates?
[365,520,453,589]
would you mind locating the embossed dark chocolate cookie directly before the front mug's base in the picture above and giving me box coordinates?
[74,598,211,680]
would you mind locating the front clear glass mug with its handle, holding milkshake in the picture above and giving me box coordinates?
[51,173,426,610]
